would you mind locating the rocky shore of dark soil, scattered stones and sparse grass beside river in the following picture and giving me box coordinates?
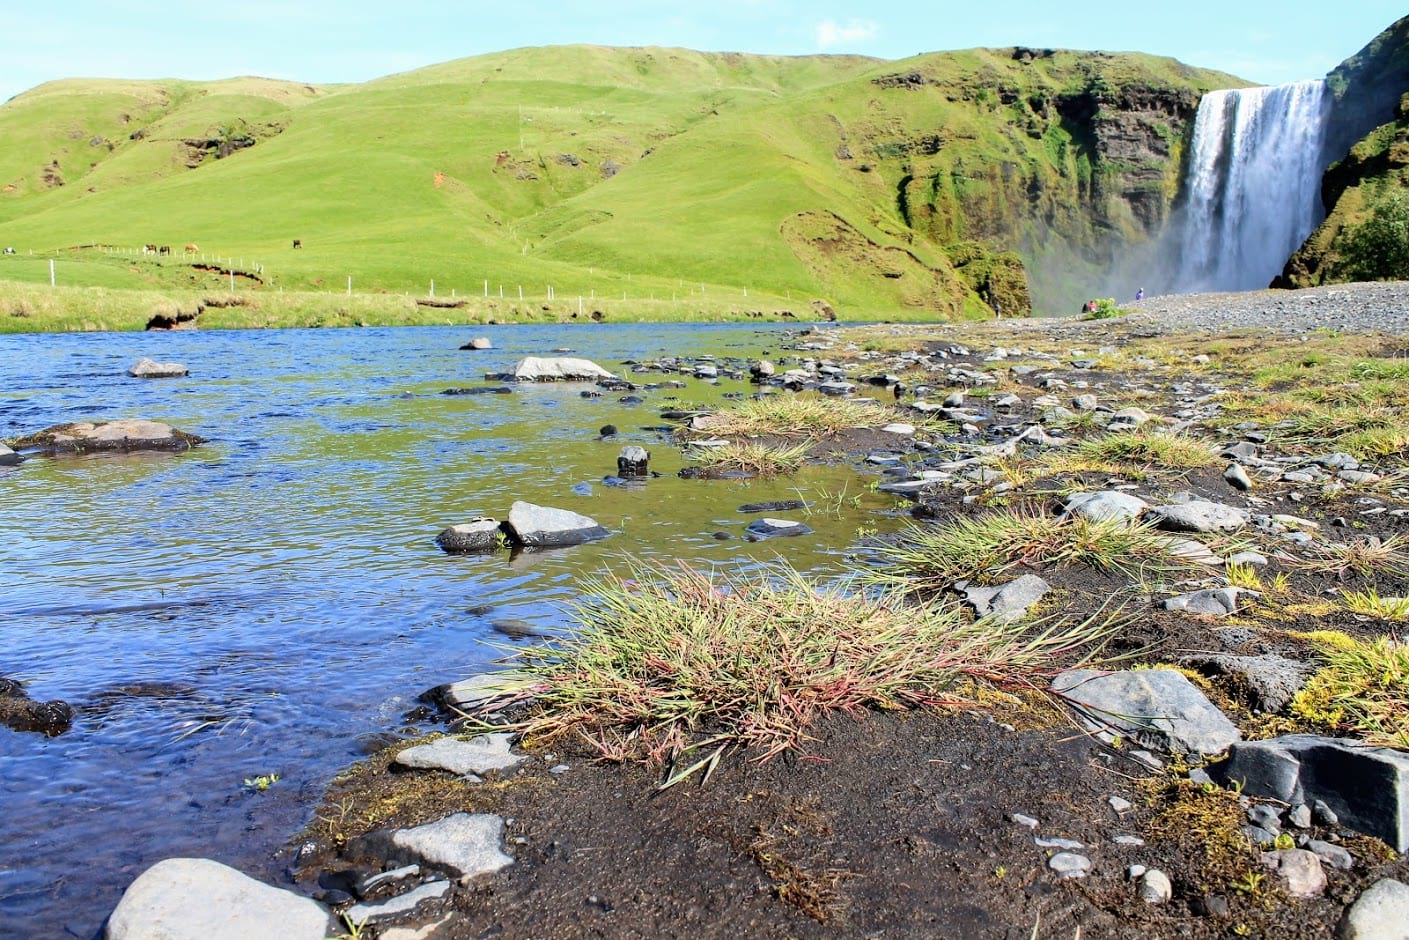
[49,285,1409,940]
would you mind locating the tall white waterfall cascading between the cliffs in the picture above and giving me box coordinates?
[1171,80,1327,292]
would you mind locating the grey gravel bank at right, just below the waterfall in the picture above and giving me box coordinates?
[1126,280,1409,333]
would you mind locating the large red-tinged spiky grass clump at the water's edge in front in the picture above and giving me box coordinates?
[501,565,1110,778]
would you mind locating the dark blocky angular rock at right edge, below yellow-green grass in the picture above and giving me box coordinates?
[1216,734,1409,851]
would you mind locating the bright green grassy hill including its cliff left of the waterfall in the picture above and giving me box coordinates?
[0,47,1240,327]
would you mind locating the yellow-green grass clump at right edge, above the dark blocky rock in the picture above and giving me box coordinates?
[1291,637,1409,748]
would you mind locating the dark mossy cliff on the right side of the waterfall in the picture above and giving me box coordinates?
[1275,17,1409,287]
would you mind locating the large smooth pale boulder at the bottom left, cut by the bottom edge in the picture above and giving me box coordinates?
[103,858,333,940]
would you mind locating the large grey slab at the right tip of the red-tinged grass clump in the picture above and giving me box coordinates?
[1053,669,1241,754]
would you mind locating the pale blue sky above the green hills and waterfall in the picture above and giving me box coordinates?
[0,0,1406,104]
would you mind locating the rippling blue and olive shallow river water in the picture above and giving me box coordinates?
[0,324,890,937]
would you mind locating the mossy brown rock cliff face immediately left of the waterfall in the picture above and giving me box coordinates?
[871,48,1239,309]
